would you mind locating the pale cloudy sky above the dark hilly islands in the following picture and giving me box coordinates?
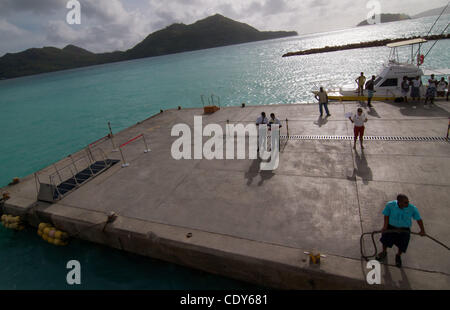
[0,0,448,56]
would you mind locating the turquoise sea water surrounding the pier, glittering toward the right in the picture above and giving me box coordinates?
[0,15,450,289]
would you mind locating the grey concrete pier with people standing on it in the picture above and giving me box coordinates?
[2,101,450,289]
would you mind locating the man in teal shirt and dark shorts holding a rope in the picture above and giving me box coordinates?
[377,194,425,267]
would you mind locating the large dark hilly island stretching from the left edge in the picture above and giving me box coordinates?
[0,14,298,79]
